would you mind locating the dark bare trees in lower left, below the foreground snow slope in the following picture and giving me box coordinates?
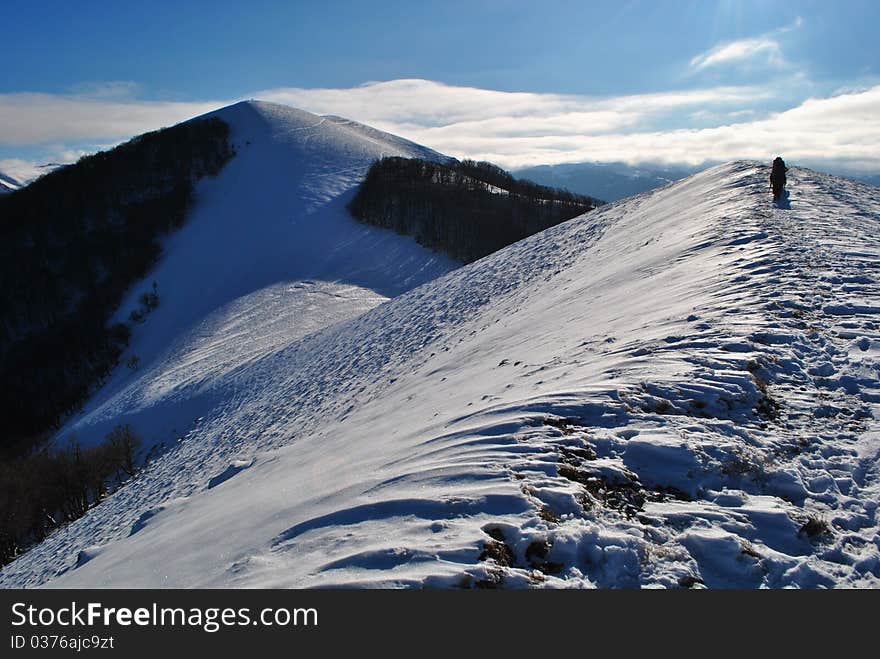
[0,426,140,565]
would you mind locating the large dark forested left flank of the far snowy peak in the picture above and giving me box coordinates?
[0,118,234,459]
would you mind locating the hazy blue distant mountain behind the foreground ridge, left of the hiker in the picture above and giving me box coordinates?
[514,162,694,201]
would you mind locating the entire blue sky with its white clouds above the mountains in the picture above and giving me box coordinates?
[0,0,880,178]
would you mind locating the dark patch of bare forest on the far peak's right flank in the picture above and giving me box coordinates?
[349,157,602,263]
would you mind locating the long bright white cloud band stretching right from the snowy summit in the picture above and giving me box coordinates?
[258,80,880,170]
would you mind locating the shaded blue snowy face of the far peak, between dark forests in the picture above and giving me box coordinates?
[59,101,458,454]
